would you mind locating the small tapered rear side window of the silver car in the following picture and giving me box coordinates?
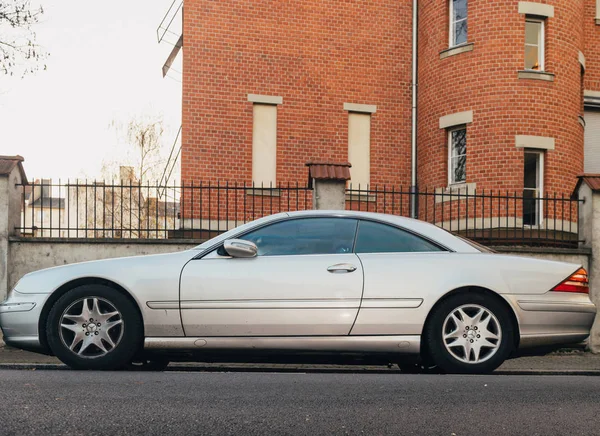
[355,221,445,253]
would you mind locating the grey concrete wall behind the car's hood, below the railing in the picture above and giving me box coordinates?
[8,238,200,289]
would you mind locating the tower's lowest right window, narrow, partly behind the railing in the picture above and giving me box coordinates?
[523,151,544,226]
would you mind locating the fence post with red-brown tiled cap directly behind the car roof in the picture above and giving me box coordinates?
[306,161,351,210]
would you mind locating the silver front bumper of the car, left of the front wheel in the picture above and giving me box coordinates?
[0,291,48,353]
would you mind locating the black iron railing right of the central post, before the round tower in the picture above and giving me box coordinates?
[346,186,583,248]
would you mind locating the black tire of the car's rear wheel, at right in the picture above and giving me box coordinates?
[423,292,515,374]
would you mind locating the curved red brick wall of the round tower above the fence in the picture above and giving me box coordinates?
[419,0,583,194]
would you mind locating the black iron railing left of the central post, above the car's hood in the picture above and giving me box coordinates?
[18,181,312,239]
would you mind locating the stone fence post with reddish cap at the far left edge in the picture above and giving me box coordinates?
[0,156,27,301]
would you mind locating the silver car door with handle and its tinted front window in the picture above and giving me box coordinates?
[180,217,363,337]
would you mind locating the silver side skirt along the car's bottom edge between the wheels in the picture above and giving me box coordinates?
[144,335,421,354]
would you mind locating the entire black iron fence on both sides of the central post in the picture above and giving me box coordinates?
[18,181,581,248]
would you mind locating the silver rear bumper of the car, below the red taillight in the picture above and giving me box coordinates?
[505,292,596,349]
